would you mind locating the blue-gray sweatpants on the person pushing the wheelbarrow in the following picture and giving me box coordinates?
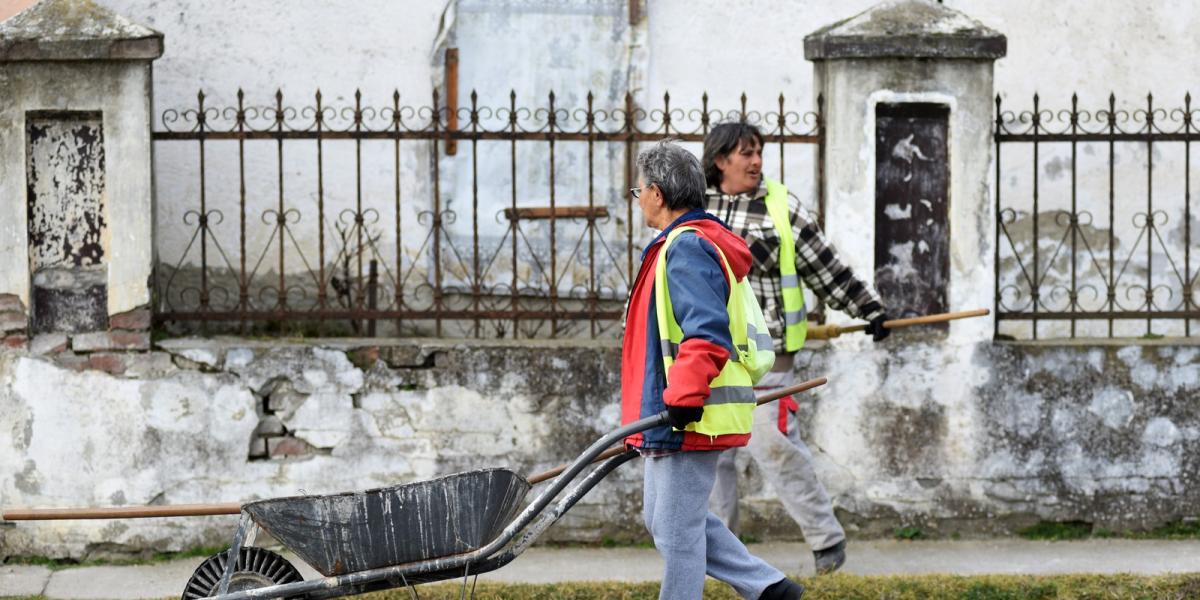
[642,451,784,600]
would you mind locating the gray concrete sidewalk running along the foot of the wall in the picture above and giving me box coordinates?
[0,540,1200,600]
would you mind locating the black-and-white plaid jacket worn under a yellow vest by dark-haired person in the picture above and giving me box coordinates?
[706,184,884,353]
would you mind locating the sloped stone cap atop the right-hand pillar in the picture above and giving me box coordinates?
[804,0,1008,60]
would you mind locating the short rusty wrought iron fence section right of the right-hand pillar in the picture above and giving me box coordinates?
[995,95,1200,340]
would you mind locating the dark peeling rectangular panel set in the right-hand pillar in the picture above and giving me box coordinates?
[875,103,950,318]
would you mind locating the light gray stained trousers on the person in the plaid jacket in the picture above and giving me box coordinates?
[709,356,846,551]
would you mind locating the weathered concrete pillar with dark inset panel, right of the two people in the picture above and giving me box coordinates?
[804,0,1007,341]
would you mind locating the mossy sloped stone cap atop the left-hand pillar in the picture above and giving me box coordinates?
[0,0,162,62]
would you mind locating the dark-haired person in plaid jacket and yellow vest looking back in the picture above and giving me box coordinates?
[701,122,889,574]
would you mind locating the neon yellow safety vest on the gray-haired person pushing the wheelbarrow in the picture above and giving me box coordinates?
[654,227,755,436]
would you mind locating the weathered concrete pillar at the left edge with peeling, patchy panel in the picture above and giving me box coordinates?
[0,0,162,352]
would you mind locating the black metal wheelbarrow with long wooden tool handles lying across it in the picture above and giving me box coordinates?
[4,378,826,600]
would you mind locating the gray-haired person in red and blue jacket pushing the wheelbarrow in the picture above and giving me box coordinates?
[620,138,804,600]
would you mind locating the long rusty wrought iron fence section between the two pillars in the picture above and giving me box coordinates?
[152,90,823,337]
